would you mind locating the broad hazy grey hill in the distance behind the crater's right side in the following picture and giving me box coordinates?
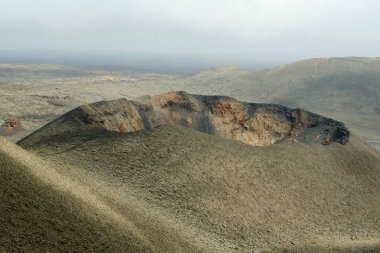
[243,58,380,118]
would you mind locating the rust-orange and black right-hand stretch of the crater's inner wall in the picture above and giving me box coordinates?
[151,92,350,146]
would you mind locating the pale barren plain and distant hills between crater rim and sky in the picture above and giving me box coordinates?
[0,58,380,148]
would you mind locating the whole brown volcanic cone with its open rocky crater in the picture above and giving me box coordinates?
[3,92,380,252]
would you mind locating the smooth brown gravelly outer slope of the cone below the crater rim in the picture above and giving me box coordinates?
[13,96,380,252]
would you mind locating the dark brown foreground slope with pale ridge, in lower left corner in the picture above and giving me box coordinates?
[0,137,156,252]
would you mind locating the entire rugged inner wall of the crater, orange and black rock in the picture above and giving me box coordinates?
[18,92,350,146]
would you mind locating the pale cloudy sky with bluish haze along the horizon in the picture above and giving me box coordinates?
[0,0,380,70]
